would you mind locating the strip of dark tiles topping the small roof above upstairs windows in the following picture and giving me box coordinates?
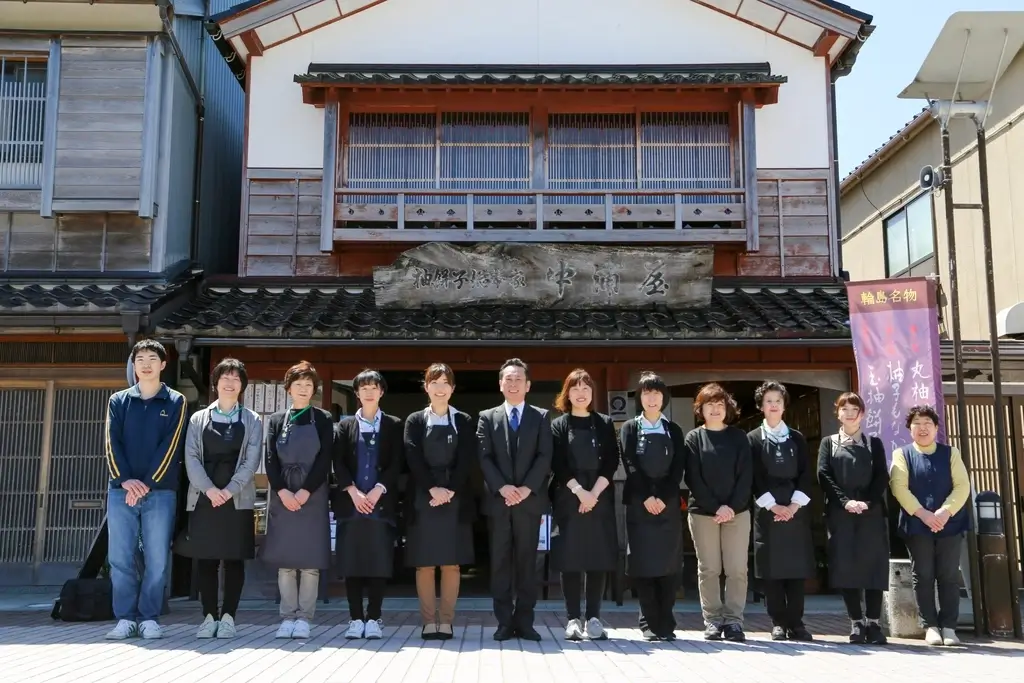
[295,62,786,86]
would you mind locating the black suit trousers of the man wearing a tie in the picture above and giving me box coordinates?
[487,502,541,628]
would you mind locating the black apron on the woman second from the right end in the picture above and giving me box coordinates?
[825,438,889,591]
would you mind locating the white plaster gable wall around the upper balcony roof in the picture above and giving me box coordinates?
[248,0,828,168]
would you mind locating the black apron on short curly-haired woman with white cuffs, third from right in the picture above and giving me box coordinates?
[754,436,815,580]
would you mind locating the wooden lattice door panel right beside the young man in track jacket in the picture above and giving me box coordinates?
[42,389,111,564]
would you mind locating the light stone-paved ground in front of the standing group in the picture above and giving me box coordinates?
[0,609,1024,683]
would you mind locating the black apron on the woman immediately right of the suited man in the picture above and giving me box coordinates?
[551,419,618,572]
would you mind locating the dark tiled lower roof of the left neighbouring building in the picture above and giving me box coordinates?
[0,273,195,315]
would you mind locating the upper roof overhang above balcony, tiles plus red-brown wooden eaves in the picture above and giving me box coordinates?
[295,62,786,104]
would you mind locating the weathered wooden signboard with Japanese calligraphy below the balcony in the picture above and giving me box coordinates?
[374,242,715,308]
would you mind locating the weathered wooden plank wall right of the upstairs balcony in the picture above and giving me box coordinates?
[735,168,833,278]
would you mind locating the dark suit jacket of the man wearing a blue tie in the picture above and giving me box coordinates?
[476,403,554,514]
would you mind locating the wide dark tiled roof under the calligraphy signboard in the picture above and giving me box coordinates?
[157,284,850,343]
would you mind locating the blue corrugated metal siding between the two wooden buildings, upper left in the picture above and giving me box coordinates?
[195,0,245,273]
